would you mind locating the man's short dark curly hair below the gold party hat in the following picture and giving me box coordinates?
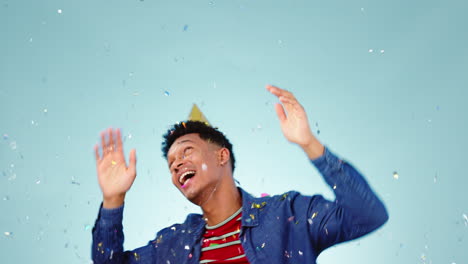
[161,120,236,172]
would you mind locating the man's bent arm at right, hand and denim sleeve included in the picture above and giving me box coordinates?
[266,85,388,252]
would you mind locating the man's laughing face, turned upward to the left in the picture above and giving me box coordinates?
[167,133,222,205]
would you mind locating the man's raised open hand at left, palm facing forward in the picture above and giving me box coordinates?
[94,128,136,208]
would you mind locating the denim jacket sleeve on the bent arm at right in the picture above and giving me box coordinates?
[302,147,388,252]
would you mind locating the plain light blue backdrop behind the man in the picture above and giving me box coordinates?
[0,0,468,264]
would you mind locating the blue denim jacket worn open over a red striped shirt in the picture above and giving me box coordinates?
[92,147,388,264]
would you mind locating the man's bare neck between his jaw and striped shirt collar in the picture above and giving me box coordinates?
[202,182,242,226]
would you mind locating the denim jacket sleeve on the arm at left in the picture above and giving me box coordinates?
[91,204,156,264]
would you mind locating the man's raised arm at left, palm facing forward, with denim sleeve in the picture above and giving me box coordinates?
[91,128,139,263]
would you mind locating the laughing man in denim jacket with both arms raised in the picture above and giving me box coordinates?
[92,85,388,264]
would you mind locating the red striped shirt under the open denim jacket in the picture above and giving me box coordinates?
[200,207,249,264]
